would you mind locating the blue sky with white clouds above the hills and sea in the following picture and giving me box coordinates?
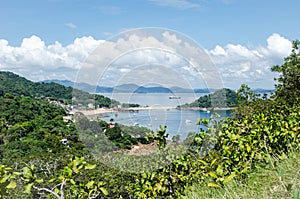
[0,0,300,89]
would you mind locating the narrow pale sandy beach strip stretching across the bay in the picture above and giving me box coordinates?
[72,106,235,115]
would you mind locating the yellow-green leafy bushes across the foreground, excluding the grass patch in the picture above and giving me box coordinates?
[0,41,300,199]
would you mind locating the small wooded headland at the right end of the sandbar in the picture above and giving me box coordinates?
[178,88,237,108]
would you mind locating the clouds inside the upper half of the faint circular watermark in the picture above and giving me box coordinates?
[77,28,222,88]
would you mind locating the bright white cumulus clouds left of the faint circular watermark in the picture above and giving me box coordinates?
[0,35,102,81]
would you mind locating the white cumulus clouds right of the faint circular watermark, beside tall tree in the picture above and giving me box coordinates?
[207,33,292,88]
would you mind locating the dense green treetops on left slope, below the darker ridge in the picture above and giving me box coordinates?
[0,95,83,163]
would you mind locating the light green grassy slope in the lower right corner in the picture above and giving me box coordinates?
[184,152,300,199]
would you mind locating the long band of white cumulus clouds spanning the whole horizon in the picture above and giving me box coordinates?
[0,31,292,88]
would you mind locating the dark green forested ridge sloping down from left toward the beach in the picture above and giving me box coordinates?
[0,71,119,107]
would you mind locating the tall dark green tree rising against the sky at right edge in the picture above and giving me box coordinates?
[271,40,300,103]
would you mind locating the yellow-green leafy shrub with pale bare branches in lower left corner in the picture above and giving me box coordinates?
[0,157,108,199]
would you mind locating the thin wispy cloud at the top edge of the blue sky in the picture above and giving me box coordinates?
[149,0,200,10]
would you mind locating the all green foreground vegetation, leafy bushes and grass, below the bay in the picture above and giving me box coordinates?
[0,41,300,199]
